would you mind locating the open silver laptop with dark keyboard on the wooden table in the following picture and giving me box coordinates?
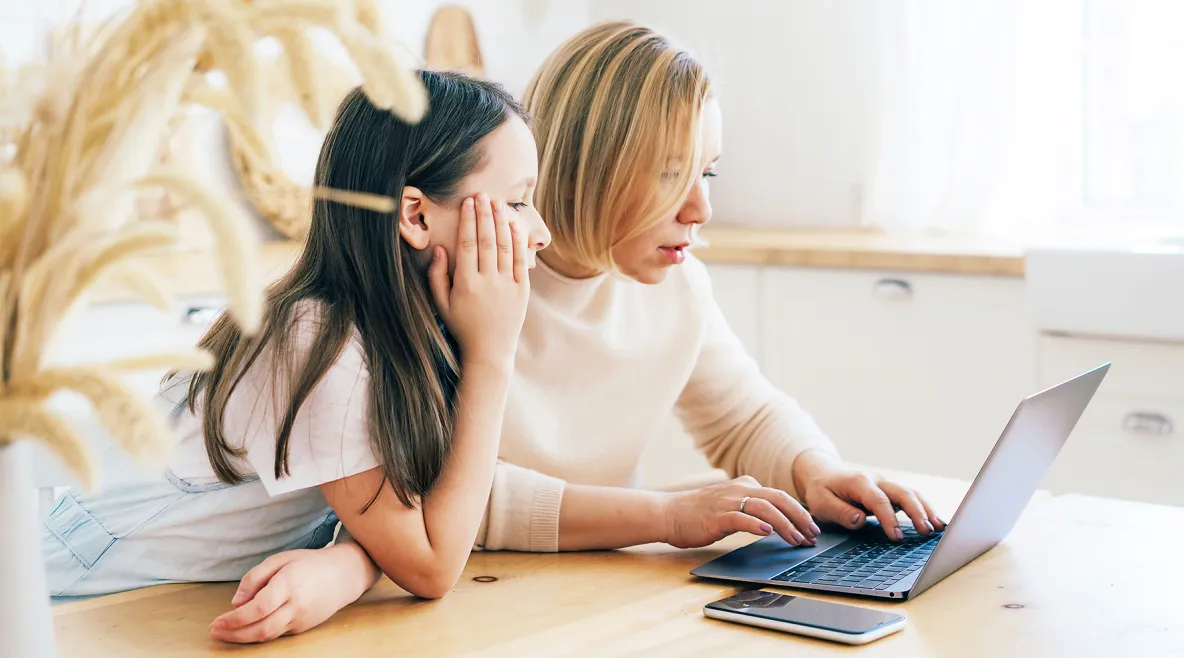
[690,363,1111,601]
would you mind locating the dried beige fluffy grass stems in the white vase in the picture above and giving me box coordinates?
[0,0,426,485]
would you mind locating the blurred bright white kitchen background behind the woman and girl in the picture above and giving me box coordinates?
[9,0,1184,504]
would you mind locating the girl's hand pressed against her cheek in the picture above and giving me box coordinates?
[427,193,530,367]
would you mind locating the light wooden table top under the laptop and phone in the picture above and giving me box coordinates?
[54,476,1184,658]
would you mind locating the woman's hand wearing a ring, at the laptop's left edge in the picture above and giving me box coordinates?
[664,476,822,548]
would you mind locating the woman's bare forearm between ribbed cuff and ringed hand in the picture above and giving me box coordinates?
[559,483,670,550]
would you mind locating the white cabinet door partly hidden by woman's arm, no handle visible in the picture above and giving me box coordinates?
[641,264,760,486]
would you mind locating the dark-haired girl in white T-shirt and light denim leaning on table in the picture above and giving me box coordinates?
[43,72,551,606]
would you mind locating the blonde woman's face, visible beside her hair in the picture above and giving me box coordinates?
[612,97,723,283]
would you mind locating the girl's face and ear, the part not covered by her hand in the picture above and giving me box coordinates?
[399,116,551,271]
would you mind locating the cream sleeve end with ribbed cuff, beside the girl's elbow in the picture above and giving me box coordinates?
[474,462,564,553]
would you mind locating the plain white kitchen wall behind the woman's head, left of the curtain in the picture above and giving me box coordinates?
[0,0,889,226]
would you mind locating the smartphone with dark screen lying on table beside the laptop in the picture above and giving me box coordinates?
[703,589,906,644]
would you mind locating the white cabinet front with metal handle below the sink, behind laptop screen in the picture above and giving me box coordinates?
[1038,335,1184,505]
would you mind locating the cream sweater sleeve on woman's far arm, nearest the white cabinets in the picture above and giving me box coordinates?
[675,260,837,499]
